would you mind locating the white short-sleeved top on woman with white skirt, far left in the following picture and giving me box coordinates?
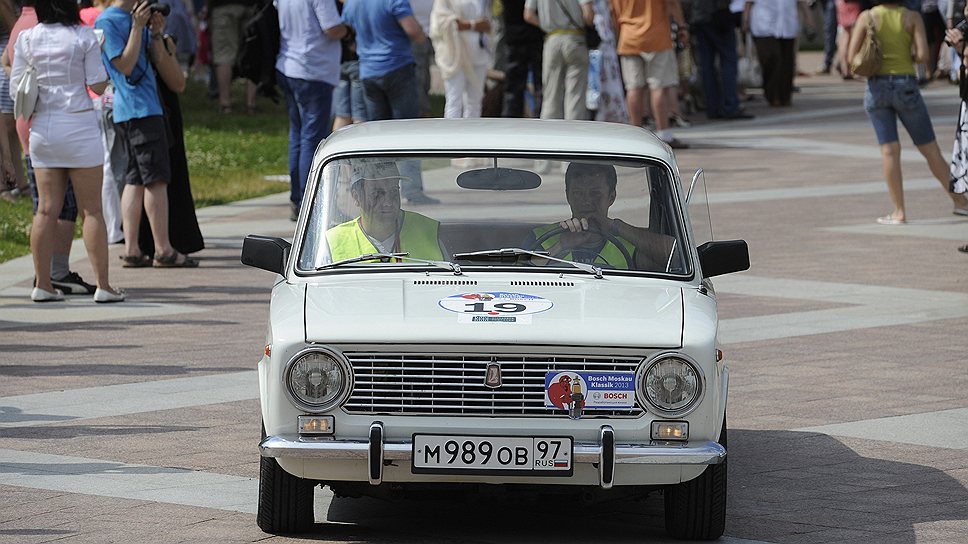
[10,24,108,113]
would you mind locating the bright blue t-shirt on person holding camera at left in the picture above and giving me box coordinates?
[94,6,163,123]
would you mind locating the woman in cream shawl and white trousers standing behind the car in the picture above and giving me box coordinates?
[430,0,491,117]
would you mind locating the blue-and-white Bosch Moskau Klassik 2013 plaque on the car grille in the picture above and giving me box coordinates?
[545,372,635,410]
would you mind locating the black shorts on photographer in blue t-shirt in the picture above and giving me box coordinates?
[115,115,171,185]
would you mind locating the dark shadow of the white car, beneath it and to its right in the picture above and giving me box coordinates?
[266,429,968,544]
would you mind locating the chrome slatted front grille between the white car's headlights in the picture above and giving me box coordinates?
[343,352,643,418]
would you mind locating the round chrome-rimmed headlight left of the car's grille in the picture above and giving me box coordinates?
[284,347,352,412]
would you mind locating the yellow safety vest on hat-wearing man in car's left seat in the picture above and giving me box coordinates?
[326,211,443,262]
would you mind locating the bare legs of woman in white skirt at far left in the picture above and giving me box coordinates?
[30,166,114,292]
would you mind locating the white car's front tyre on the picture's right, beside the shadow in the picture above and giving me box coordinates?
[665,417,729,540]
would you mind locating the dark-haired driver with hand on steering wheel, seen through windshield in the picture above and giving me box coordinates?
[526,162,672,270]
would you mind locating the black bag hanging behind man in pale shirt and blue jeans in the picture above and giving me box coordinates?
[235,0,279,103]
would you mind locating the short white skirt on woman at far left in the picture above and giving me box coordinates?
[30,110,104,168]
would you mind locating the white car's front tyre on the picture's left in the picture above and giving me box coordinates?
[256,424,315,534]
